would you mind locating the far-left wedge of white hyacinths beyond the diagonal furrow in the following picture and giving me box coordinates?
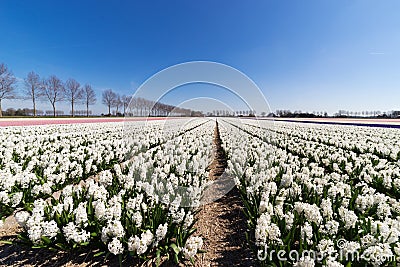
[0,120,200,223]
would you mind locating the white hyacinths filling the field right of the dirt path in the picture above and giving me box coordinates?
[220,119,400,266]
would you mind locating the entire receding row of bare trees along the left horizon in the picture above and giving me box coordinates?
[0,63,201,117]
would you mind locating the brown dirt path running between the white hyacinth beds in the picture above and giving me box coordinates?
[195,123,257,267]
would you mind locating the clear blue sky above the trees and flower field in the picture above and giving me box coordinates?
[0,0,400,113]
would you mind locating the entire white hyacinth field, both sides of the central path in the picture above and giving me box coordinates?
[0,118,400,266]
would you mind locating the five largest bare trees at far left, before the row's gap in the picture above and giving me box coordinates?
[0,63,96,116]
